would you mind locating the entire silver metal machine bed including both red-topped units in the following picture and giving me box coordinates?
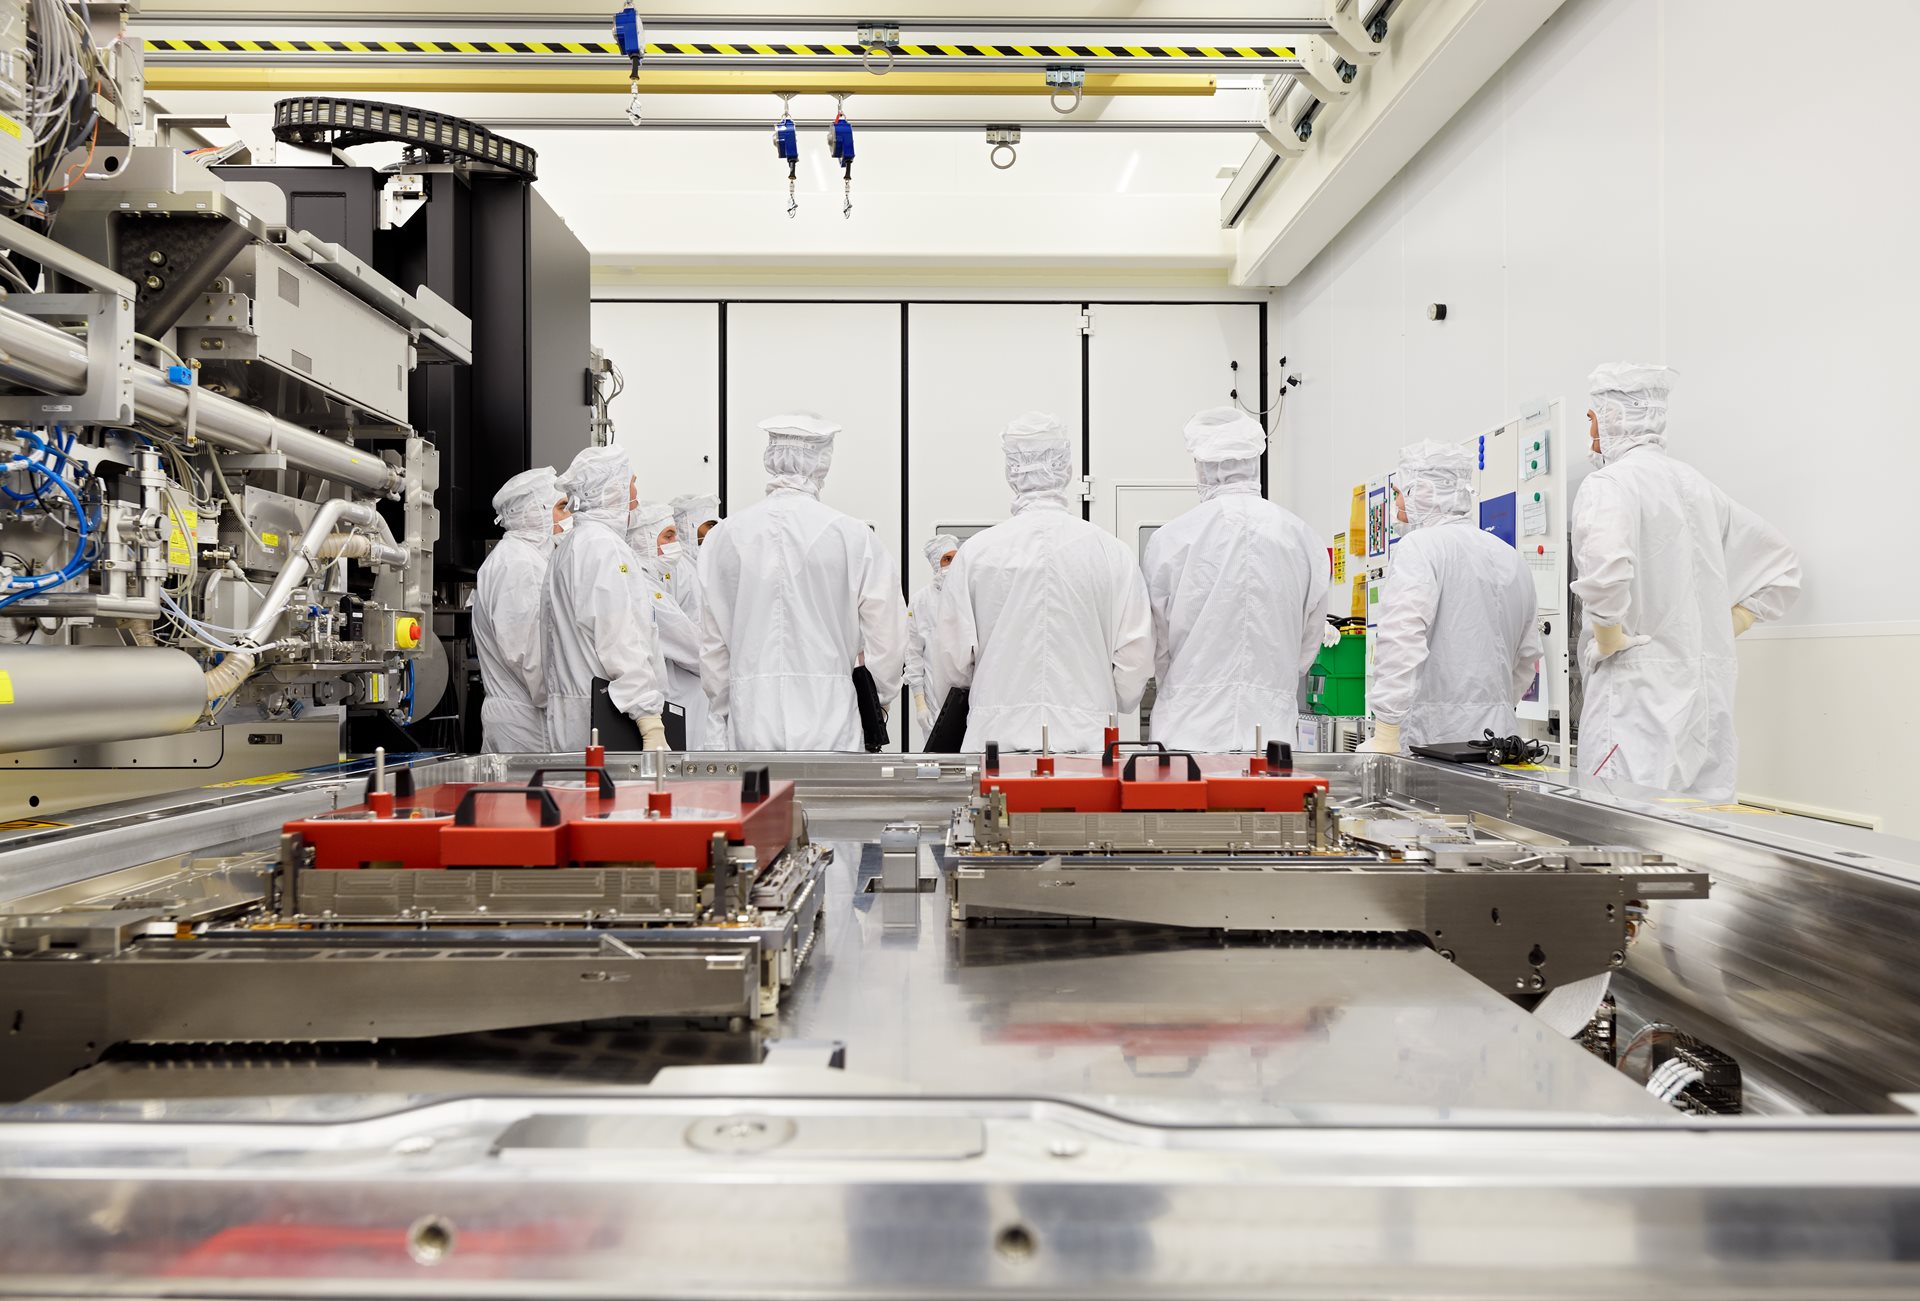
[0,748,1920,1297]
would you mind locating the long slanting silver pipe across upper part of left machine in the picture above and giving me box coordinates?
[0,307,405,493]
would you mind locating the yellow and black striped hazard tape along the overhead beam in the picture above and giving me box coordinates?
[142,36,1298,63]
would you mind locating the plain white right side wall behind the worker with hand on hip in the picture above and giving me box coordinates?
[1271,0,1920,835]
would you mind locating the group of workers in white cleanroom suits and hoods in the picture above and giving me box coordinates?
[474,365,1799,798]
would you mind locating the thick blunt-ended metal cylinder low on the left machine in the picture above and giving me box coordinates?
[0,647,207,752]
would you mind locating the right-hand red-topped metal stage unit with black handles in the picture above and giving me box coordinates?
[950,741,1707,998]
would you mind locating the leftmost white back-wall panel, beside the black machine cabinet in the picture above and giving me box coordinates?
[587,303,720,501]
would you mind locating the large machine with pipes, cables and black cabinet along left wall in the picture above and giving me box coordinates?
[0,0,605,819]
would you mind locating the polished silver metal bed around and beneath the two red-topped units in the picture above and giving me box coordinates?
[0,754,1920,1297]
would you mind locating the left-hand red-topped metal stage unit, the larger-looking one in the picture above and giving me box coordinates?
[0,746,817,1096]
